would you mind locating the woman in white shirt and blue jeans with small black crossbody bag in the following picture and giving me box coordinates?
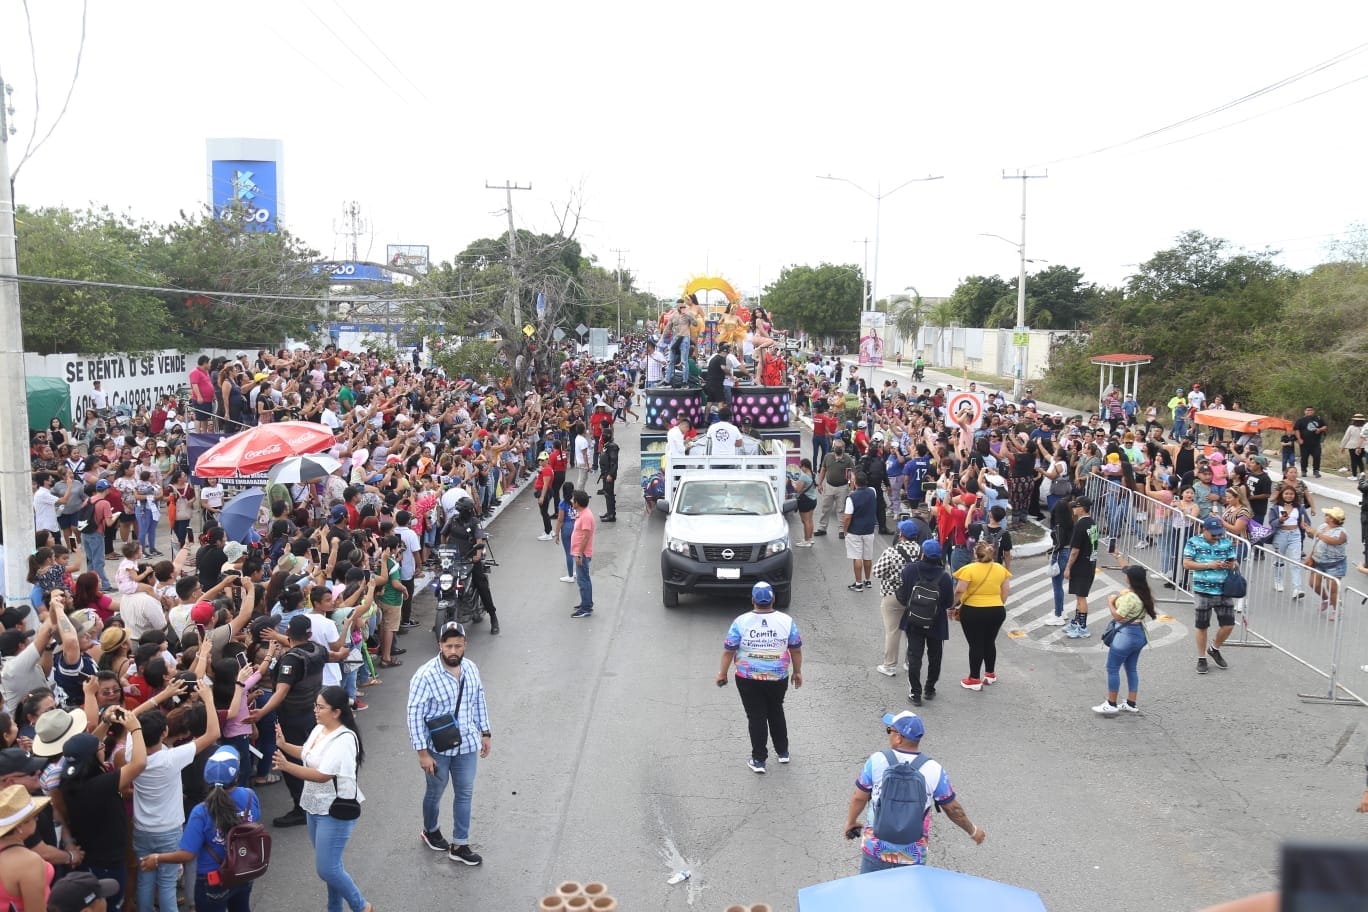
[275,685,373,912]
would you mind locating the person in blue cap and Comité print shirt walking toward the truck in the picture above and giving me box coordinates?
[717,581,803,773]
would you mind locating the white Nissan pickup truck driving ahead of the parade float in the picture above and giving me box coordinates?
[659,440,796,610]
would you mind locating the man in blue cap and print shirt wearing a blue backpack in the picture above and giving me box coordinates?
[844,711,988,874]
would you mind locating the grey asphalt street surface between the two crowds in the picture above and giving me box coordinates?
[254,415,1368,912]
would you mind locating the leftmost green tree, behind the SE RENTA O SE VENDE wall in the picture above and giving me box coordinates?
[15,206,170,354]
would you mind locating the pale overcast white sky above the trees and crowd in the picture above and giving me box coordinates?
[0,0,1368,306]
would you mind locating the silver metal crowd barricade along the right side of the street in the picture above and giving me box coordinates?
[1085,476,1368,706]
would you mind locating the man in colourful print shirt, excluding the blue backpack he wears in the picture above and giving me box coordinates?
[844,711,988,874]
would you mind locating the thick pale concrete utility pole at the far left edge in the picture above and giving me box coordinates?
[0,71,36,607]
